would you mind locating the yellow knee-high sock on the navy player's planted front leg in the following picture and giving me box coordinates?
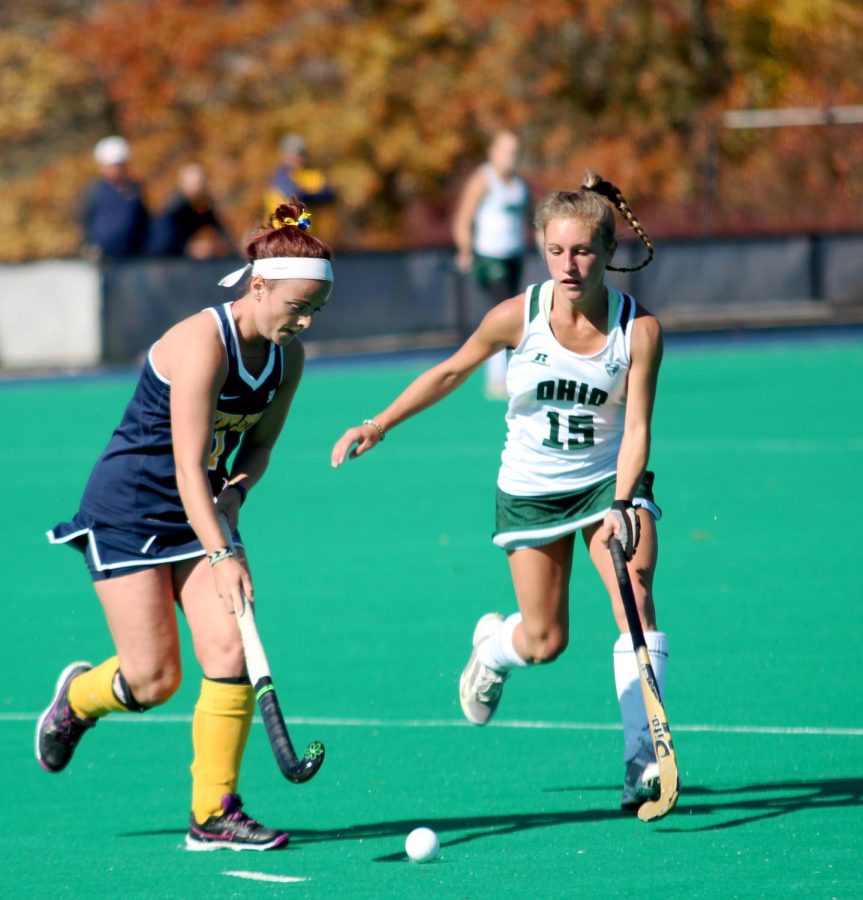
[192,678,255,825]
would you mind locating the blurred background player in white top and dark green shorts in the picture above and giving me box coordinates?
[453,131,530,399]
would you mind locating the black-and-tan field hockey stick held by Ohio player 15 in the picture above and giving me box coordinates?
[608,538,680,822]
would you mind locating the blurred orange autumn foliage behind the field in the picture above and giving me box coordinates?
[0,0,863,260]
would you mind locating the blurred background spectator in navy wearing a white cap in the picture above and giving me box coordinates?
[80,135,150,259]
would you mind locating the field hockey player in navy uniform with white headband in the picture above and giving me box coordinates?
[36,201,333,850]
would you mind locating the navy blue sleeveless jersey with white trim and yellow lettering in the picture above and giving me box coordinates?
[80,303,284,535]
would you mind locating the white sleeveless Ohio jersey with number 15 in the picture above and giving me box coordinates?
[497,281,635,497]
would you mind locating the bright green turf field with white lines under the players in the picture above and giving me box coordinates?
[0,339,863,900]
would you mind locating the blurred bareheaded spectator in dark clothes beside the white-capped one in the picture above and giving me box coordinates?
[150,163,236,259]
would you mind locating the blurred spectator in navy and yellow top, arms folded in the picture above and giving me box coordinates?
[264,134,338,244]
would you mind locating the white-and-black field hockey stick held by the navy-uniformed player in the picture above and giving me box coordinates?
[219,513,324,784]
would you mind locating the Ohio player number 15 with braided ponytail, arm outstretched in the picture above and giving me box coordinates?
[332,172,668,810]
